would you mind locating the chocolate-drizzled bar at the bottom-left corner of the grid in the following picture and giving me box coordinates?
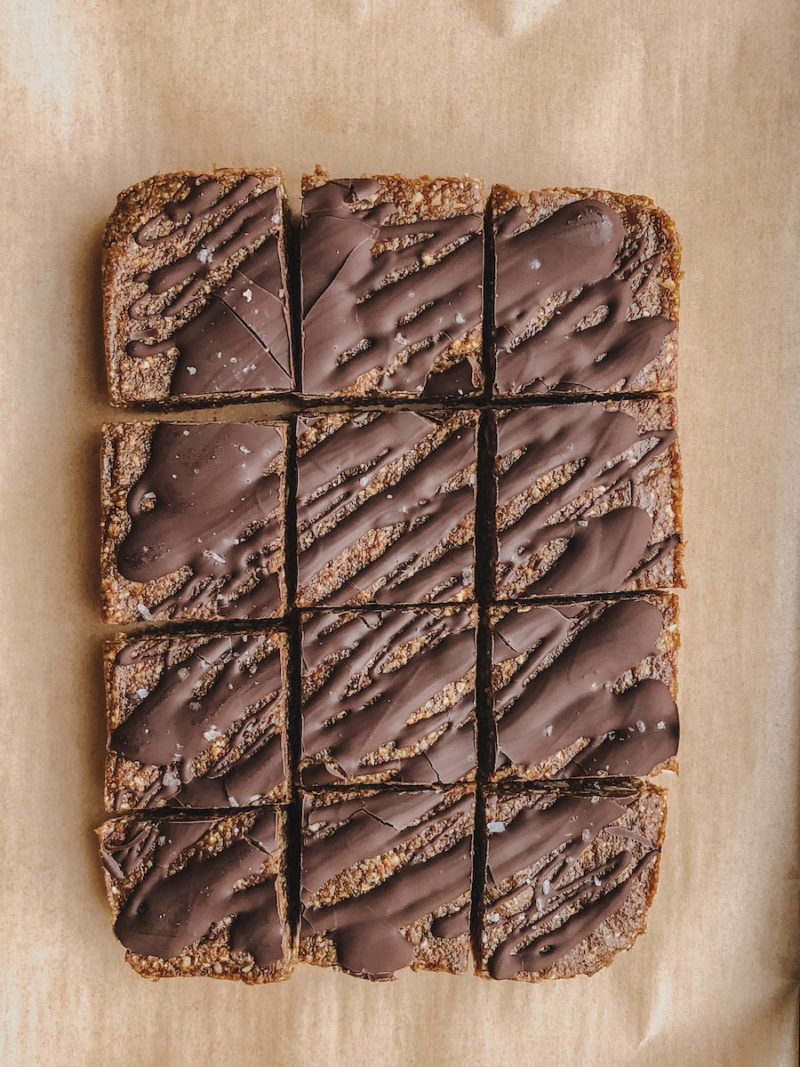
[98,809,293,983]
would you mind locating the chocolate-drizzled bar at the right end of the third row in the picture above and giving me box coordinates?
[492,595,679,779]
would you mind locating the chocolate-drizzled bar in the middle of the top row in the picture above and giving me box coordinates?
[301,170,485,398]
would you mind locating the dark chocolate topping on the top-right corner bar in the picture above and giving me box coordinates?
[495,200,675,393]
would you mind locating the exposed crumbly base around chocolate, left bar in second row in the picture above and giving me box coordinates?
[100,421,287,624]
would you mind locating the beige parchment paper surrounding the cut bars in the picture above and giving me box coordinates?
[0,0,800,1067]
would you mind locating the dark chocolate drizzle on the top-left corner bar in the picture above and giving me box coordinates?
[127,175,292,396]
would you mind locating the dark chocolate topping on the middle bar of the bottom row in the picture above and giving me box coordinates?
[301,792,474,978]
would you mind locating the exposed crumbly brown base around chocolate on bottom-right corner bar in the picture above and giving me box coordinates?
[476,784,667,983]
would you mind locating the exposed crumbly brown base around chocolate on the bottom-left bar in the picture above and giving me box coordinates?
[97,808,297,985]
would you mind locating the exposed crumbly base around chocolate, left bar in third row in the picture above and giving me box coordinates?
[103,630,289,812]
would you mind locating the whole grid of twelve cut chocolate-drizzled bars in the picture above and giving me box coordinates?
[99,171,683,982]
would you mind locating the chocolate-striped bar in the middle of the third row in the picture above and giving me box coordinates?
[300,607,477,785]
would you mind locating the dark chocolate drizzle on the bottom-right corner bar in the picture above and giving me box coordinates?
[484,796,659,978]
